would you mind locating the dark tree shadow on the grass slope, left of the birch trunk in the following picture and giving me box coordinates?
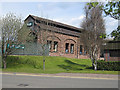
[58,60,88,71]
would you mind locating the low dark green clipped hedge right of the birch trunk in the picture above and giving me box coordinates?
[97,60,120,71]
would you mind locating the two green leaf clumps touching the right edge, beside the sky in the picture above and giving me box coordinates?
[103,0,120,40]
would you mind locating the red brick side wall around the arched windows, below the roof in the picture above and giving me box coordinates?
[38,31,88,59]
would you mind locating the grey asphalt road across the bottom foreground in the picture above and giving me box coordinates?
[2,74,118,88]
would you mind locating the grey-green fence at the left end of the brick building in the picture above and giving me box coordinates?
[12,43,49,56]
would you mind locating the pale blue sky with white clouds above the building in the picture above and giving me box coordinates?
[0,2,118,34]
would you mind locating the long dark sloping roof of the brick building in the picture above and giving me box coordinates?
[25,15,82,37]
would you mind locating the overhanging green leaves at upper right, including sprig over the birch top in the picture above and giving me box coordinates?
[87,0,120,40]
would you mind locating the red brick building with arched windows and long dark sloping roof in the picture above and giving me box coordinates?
[25,15,88,58]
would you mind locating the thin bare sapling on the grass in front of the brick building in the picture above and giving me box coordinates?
[37,16,54,70]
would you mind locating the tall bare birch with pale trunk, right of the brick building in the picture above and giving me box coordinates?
[81,4,105,70]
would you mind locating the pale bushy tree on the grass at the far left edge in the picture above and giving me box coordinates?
[0,13,22,68]
